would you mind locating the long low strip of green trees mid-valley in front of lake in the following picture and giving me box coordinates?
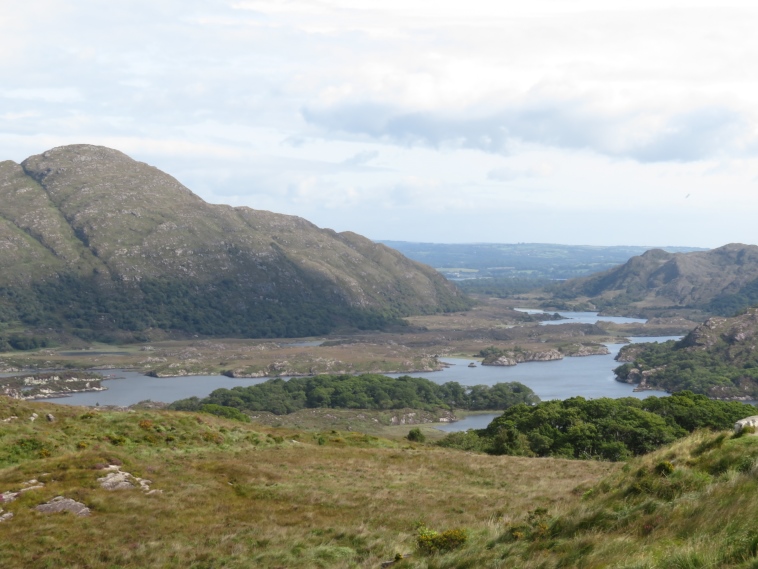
[170,374,539,415]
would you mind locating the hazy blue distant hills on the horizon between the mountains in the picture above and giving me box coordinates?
[380,241,702,280]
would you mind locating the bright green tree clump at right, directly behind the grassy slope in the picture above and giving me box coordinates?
[439,391,755,461]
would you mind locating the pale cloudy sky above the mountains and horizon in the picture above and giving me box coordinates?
[0,0,758,247]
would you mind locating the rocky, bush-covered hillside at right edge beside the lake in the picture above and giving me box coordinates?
[615,308,758,399]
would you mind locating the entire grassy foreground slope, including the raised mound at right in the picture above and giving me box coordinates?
[0,399,758,569]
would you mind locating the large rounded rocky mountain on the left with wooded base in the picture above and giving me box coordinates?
[0,145,467,339]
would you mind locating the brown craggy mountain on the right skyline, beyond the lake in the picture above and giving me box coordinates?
[555,243,758,315]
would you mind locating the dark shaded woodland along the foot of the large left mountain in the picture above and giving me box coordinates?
[0,275,440,349]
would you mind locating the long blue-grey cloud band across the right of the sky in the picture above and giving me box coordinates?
[302,101,757,162]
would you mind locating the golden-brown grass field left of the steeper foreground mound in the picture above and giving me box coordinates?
[0,398,616,568]
